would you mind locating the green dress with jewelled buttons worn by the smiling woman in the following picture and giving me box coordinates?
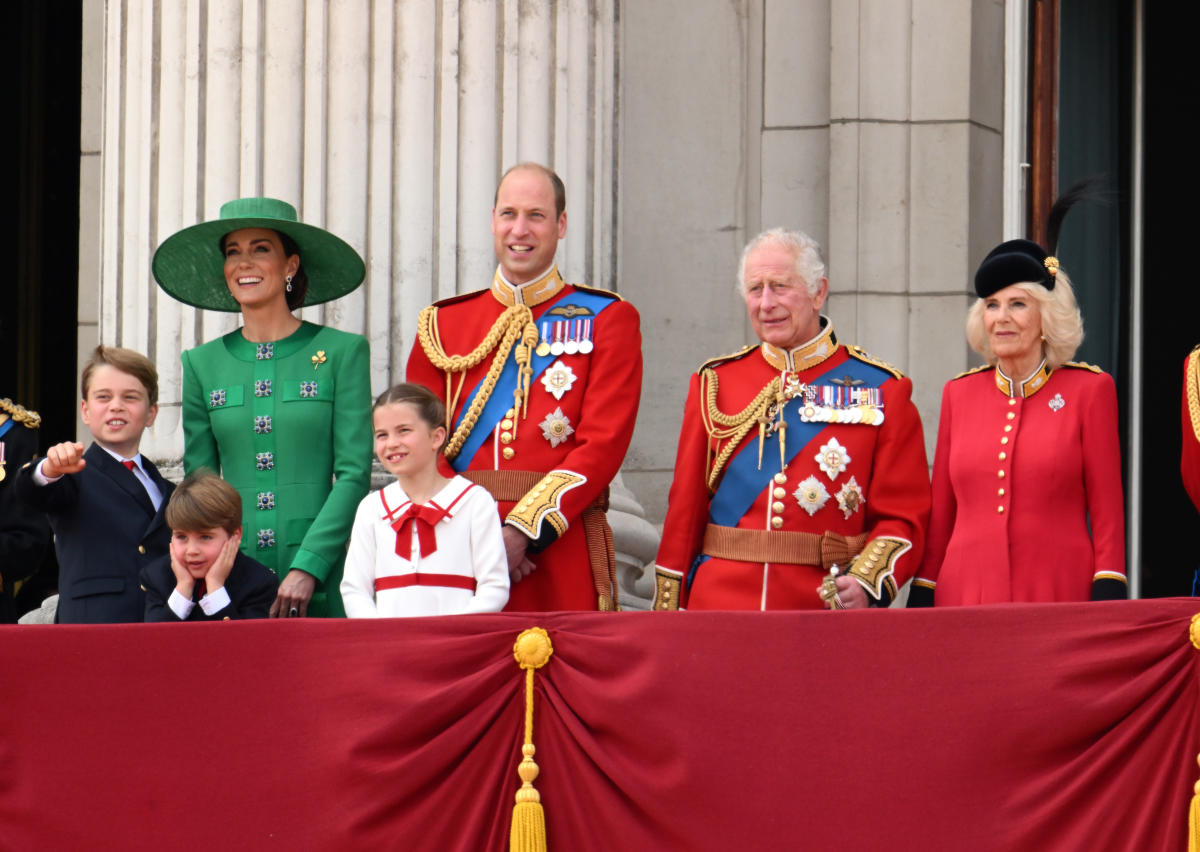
[182,323,373,616]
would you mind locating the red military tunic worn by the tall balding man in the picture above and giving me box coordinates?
[407,269,642,611]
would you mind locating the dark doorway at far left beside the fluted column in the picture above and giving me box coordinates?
[0,0,83,450]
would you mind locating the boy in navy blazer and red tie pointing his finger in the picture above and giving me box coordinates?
[14,346,175,624]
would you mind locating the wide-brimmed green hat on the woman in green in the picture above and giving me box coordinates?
[150,198,366,311]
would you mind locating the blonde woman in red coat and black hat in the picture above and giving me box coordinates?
[908,240,1126,606]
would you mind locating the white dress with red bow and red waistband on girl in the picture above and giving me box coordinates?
[341,476,509,618]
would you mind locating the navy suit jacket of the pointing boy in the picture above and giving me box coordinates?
[14,444,175,624]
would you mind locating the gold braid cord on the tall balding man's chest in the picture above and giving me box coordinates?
[416,305,538,460]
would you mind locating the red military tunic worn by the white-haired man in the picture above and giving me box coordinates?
[655,324,930,610]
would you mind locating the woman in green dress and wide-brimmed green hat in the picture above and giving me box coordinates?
[152,198,372,618]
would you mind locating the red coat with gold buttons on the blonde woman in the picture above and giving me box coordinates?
[913,364,1126,606]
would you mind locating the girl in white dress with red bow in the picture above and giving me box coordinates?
[341,384,509,618]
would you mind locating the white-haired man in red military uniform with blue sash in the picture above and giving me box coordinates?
[655,228,930,610]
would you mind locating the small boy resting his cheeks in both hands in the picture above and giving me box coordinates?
[142,472,280,622]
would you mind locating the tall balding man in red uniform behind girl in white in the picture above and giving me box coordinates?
[407,163,642,611]
